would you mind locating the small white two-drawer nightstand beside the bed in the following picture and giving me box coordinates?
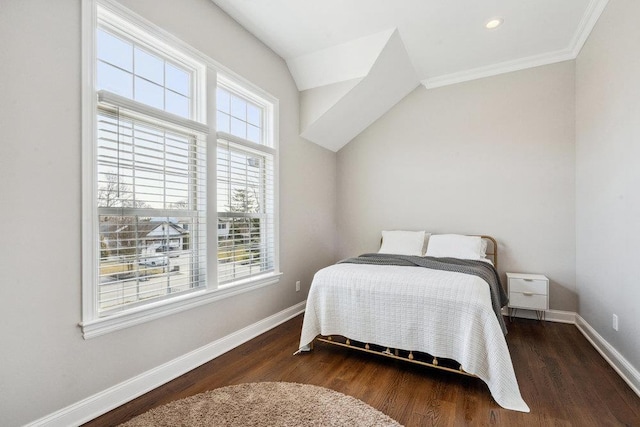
[507,273,549,320]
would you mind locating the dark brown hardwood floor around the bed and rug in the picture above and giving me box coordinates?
[85,316,640,426]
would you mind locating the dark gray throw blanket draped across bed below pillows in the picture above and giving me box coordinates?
[338,253,509,335]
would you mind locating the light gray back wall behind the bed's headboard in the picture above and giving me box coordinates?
[338,62,577,311]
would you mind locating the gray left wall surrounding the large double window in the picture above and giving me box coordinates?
[0,0,336,426]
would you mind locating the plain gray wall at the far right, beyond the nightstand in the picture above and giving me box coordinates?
[576,0,640,369]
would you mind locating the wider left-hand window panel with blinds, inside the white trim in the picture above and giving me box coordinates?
[95,15,208,317]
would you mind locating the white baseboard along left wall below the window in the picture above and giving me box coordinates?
[27,301,306,427]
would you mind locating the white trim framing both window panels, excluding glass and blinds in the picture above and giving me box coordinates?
[79,0,282,339]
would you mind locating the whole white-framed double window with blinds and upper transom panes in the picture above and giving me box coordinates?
[81,1,280,338]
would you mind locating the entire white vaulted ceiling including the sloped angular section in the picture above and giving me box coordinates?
[213,0,608,151]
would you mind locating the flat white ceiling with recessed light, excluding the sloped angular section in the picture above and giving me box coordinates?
[213,0,607,87]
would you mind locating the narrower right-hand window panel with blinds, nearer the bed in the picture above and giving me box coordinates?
[216,79,275,284]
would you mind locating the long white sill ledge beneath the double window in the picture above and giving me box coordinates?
[79,273,282,339]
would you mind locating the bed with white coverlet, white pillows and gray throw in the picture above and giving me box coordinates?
[300,232,529,412]
